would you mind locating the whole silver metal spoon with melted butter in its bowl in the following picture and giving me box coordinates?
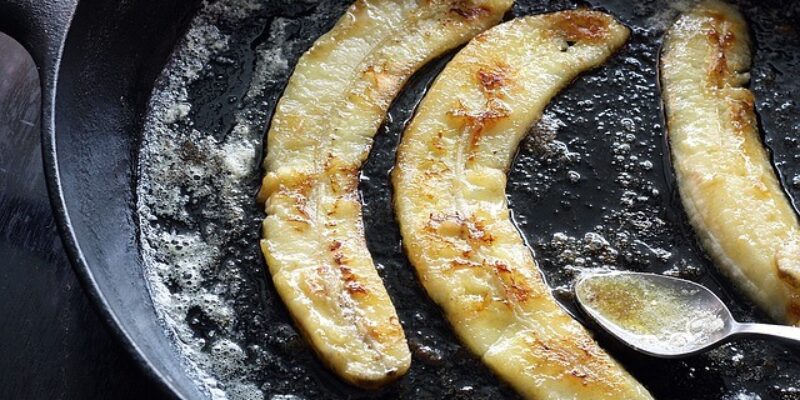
[575,272,800,358]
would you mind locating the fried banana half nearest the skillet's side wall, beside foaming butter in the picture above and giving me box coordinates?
[259,0,512,387]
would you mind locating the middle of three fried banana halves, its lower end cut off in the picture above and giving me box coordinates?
[392,11,651,400]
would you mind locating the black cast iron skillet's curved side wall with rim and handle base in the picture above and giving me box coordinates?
[0,0,202,399]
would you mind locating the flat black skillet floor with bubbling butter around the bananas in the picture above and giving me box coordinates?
[135,0,800,400]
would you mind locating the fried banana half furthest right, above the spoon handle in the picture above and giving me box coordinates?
[661,1,800,324]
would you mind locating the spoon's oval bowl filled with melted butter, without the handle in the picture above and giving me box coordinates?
[578,274,725,350]
